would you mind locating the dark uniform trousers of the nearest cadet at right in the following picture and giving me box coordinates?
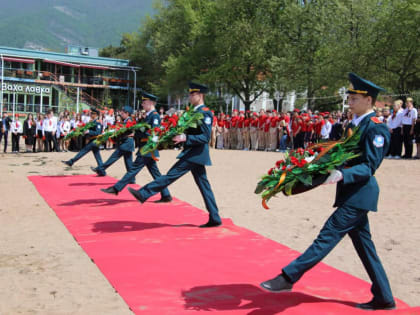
[283,206,394,303]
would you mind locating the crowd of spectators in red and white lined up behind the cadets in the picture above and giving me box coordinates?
[0,98,420,159]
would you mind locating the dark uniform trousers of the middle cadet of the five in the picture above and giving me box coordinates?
[114,153,171,198]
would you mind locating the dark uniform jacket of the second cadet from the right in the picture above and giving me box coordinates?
[177,105,213,165]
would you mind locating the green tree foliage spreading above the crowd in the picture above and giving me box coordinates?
[101,0,420,109]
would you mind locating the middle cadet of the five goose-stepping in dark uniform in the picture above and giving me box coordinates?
[101,92,172,202]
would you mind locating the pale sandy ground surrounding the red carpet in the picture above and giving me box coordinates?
[0,145,420,314]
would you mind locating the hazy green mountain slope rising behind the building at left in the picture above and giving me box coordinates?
[0,0,153,51]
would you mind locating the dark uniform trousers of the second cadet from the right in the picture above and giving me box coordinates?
[139,159,221,222]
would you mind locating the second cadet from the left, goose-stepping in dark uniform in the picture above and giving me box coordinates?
[91,106,134,179]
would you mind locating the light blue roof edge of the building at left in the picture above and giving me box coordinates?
[0,46,129,68]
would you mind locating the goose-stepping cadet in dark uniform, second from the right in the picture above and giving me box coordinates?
[128,83,222,228]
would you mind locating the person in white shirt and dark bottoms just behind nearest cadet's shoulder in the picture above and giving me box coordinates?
[387,100,403,159]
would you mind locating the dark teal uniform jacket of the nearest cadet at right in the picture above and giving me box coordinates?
[334,113,390,211]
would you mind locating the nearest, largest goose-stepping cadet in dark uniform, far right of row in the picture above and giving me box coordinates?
[261,73,395,310]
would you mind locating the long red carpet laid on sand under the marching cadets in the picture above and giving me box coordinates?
[29,176,420,315]
